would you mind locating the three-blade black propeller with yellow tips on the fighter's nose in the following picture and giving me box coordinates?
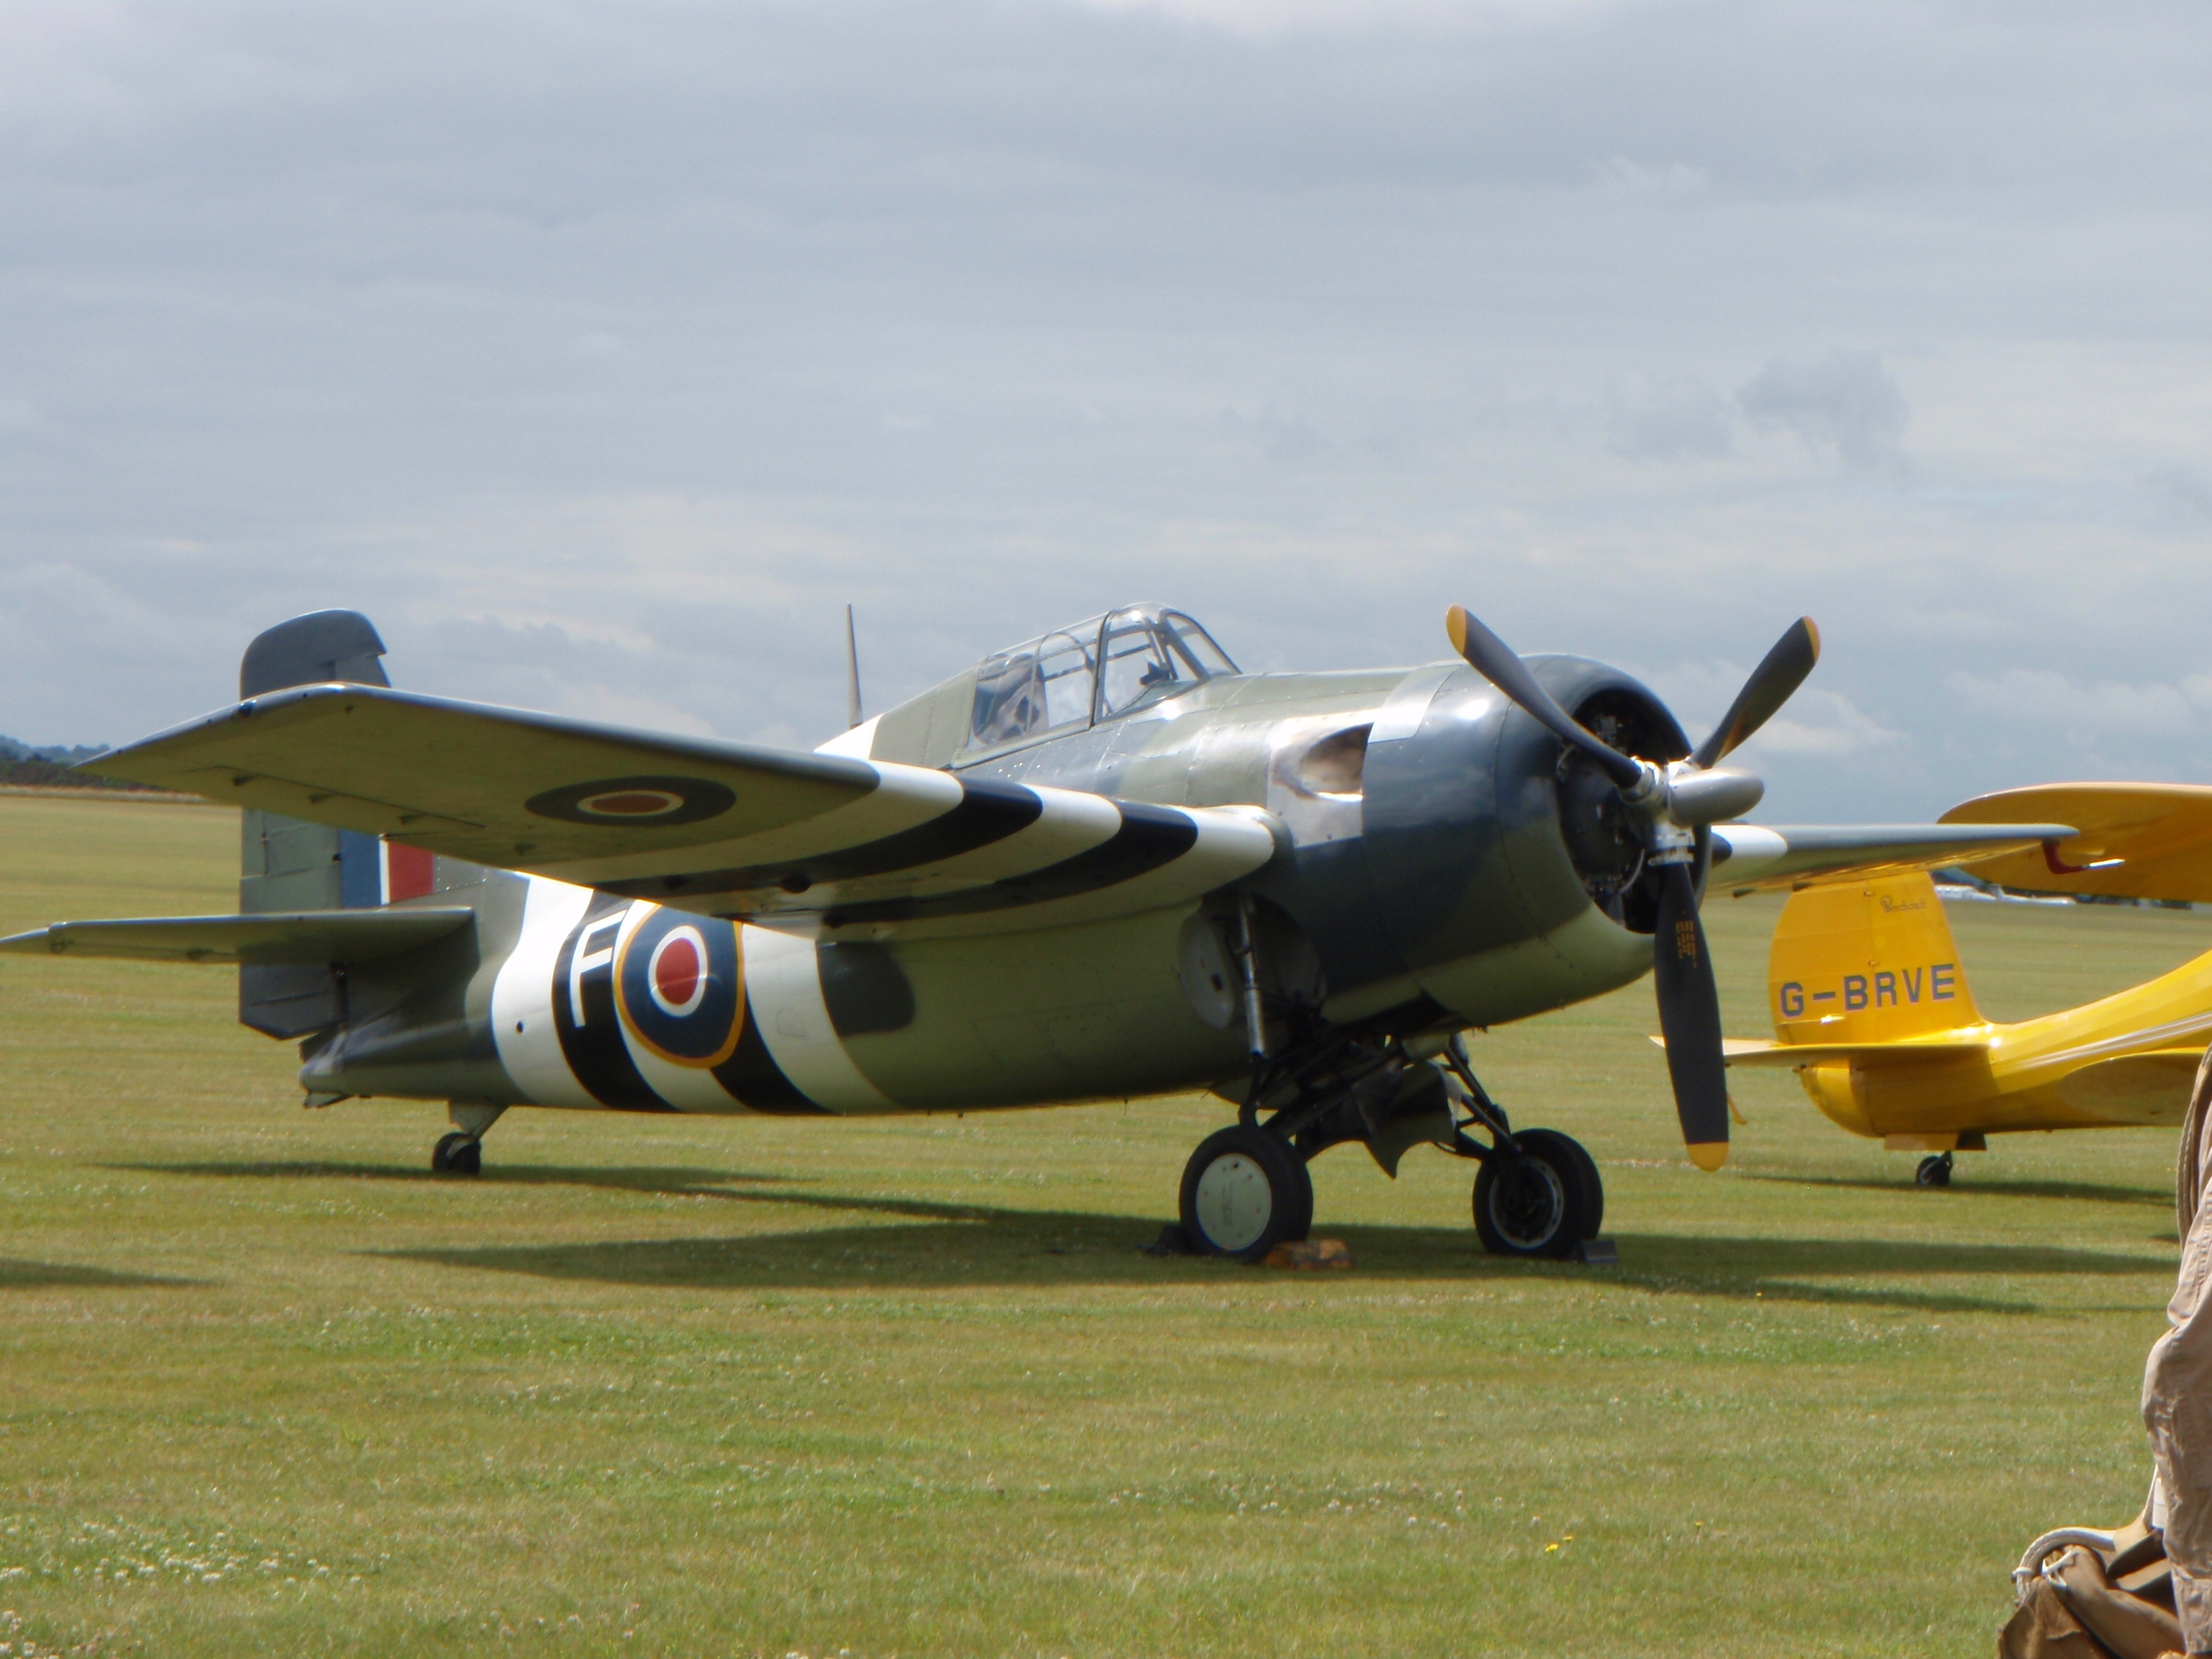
[1444,606,1820,1170]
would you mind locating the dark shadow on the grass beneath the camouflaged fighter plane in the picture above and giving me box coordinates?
[112,1161,2175,1314]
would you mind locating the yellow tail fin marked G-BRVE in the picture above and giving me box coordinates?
[1768,871,1982,1042]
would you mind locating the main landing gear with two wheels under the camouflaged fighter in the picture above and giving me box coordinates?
[1179,1031,1606,1261]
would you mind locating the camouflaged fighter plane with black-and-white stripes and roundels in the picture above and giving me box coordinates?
[4,606,2068,1259]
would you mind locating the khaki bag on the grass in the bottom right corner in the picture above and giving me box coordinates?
[1997,1519,2181,1659]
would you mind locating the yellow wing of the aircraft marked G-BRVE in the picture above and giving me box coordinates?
[1942,783,2212,904]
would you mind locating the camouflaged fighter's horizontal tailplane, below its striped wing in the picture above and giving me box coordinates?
[0,904,475,966]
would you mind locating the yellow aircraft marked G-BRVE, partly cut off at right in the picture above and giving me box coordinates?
[1725,783,2212,1186]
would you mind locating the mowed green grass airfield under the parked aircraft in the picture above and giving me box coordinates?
[0,796,2212,1659]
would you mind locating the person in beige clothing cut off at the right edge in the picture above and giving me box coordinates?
[2144,1048,2212,1655]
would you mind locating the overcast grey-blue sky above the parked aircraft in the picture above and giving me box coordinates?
[0,0,2212,821]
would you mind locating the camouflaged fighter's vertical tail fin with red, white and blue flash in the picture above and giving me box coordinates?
[239,611,429,1038]
